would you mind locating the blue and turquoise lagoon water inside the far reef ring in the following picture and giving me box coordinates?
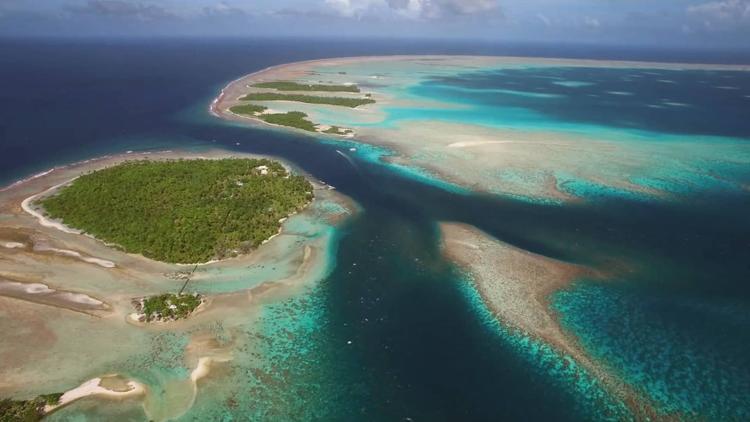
[308,62,750,202]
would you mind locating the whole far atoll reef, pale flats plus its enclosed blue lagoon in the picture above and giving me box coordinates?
[211,56,750,203]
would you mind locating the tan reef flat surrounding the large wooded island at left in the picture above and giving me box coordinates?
[0,150,356,420]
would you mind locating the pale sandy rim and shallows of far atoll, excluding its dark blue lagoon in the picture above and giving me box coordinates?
[210,55,750,204]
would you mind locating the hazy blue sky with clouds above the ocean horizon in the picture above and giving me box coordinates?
[0,0,750,47]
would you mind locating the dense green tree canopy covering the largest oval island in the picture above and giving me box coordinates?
[40,159,313,263]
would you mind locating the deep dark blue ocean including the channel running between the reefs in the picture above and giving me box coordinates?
[0,40,750,421]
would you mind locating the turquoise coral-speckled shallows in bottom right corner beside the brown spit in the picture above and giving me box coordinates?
[554,280,750,420]
